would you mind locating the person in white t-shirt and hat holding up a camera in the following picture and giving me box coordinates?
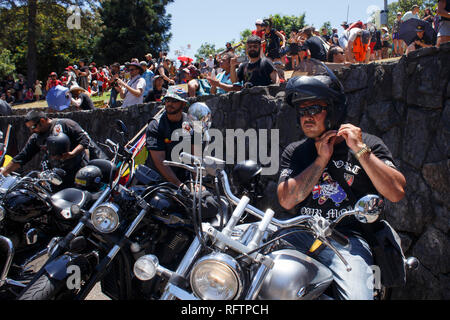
[114,62,147,108]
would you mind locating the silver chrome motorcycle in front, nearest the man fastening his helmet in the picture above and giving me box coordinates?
[133,154,417,300]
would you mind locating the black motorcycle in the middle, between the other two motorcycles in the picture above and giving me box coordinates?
[15,117,230,300]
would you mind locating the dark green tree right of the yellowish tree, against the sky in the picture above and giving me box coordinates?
[96,0,173,62]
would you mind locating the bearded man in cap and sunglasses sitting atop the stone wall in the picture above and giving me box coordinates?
[230,35,280,87]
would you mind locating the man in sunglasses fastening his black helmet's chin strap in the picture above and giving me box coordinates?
[278,65,406,300]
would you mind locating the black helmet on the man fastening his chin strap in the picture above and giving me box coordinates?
[285,59,347,130]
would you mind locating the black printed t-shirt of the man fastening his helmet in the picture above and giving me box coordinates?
[279,133,395,235]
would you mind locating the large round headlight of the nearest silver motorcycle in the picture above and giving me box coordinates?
[190,253,243,300]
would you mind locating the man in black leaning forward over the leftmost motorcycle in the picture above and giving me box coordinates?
[0,111,104,189]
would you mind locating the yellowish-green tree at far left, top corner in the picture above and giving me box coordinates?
[0,1,101,85]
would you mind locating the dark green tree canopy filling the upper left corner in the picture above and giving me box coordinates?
[0,0,173,84]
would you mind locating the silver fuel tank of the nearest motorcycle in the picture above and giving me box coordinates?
[258,249,333,300]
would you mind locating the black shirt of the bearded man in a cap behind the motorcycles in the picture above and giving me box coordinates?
[146,112,189,182]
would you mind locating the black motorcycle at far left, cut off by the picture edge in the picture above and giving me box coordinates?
[0,135,118,299]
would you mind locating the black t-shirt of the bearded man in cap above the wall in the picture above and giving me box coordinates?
[237,57,275,86]
